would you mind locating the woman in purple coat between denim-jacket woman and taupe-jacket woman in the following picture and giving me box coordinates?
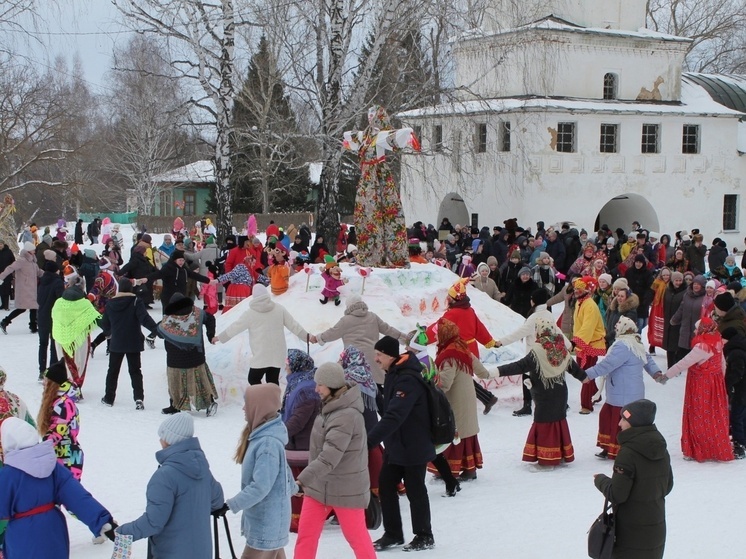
[280,349,321,532]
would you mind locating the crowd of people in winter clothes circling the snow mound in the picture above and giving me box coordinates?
[0,215,746,559]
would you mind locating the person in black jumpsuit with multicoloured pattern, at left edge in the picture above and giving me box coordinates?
[36,361,83,481]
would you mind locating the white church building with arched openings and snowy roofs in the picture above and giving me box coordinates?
[398,0,746,246]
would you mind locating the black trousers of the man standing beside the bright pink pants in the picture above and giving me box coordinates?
[378,460,433,540]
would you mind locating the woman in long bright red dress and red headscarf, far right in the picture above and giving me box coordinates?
[666,317,733,462]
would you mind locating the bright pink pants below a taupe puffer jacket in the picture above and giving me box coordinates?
[293,495,376,559]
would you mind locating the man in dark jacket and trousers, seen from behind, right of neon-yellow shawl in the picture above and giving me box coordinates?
[100,278,158,410]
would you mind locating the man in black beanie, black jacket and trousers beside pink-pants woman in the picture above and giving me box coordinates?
[368,336,435,551]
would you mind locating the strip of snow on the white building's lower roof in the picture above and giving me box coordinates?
[396,81,746,120]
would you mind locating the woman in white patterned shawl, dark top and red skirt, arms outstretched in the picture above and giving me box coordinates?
[497,318,586,469]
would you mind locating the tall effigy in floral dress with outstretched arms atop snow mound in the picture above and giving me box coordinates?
[343,106,420,268]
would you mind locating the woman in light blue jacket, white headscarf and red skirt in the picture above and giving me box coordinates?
[583,316,666,459]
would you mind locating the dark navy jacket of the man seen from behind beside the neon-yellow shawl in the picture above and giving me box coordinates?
[99,293,157,353]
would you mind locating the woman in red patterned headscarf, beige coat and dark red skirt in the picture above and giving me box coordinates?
[435,318,490,482]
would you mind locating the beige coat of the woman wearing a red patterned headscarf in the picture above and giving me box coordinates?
[438,357,490,439]
